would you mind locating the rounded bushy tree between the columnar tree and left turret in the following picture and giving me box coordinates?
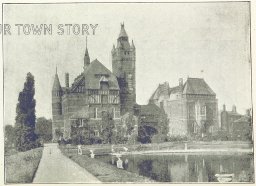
[35,117,52,142]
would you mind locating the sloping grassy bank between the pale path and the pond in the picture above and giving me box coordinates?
[60,146,154,183]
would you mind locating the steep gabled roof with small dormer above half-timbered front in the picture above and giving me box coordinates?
[72,59,119,90]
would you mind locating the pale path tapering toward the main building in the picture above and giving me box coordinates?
[33,144,100,183]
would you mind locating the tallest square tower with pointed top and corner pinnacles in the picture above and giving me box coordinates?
[111,24,136,114]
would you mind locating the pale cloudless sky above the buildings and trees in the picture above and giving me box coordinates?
[3,2,251,124]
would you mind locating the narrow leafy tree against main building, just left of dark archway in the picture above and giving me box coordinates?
[102,111,115,143]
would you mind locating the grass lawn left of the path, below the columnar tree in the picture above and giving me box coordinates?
[5,148,43,183]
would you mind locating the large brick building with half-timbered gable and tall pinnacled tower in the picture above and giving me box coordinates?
[52,24,136,140]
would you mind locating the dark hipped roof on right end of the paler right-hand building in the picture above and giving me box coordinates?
[183,78,216,96]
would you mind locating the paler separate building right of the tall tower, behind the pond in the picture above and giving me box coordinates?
[149,78,218,136]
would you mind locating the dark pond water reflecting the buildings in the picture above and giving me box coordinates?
[98,154,254,182]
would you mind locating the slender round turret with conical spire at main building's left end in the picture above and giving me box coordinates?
[52,67,64,140]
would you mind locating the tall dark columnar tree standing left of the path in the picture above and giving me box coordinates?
[15,72,37,151]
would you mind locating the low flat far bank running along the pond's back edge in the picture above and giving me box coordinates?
[60,141,253,156]
